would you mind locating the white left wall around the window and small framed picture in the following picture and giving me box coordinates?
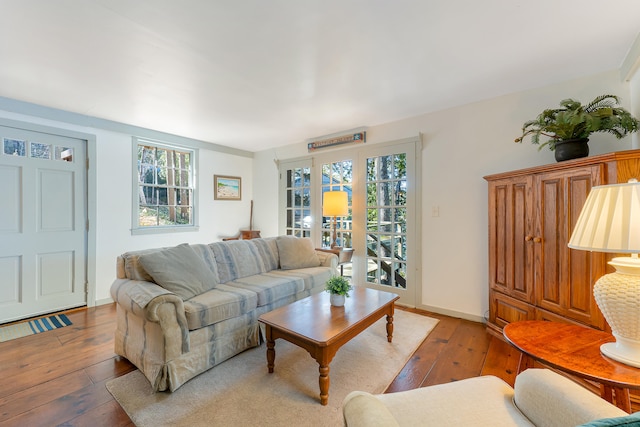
[0,110,253,304]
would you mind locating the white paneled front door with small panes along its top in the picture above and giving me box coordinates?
[0,126,87,323]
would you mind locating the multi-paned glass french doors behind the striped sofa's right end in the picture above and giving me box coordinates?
[280,138,421,306]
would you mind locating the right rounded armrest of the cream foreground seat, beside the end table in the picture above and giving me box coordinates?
[514,369,628,426]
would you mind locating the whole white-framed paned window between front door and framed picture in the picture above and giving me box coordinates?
[133,138,196,232]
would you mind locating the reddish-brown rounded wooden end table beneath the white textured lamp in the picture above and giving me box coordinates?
[503,320,640,413]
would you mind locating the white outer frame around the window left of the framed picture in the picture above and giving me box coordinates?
[131,136,199,235]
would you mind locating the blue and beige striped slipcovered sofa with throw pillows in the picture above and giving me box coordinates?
[111,236,338,391]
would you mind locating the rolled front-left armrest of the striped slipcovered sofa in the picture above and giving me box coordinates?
[111,279,189,353]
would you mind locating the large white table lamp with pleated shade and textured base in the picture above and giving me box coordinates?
[569,179,640,367]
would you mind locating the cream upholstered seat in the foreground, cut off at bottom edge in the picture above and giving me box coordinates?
[342,369,640,427]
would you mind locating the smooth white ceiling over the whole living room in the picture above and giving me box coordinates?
[0,0,640,151]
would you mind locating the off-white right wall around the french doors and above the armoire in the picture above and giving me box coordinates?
[254,70,631,320]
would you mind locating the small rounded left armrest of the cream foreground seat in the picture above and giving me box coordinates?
[342,391,398,427]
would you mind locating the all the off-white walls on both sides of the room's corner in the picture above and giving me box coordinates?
[0,70,640,320]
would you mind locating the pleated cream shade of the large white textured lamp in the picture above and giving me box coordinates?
[568,179,640,253]
